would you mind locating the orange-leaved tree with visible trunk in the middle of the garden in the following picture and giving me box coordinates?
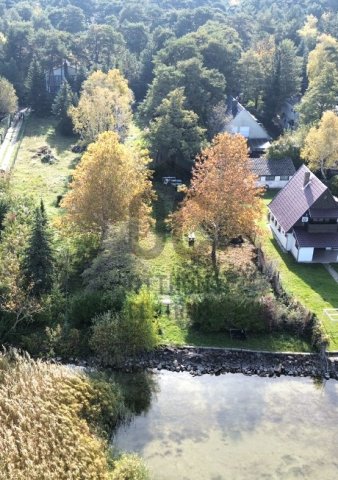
[173,133,262,267]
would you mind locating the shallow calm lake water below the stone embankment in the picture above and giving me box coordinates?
[114,372,338,480]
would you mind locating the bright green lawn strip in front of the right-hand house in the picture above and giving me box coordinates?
[262,191,338,350]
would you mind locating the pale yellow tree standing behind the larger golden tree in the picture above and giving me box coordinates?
[69,69,133,144]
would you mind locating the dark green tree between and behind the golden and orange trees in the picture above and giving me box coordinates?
[147,88,205,170]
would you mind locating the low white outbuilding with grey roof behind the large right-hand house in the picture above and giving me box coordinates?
[251,157,296,188]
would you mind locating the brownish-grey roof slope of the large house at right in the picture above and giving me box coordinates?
[269,165,328,232]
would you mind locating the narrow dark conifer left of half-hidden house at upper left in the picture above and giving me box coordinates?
[26,58,50,116]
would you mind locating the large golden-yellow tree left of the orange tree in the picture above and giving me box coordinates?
[61,132,152,238]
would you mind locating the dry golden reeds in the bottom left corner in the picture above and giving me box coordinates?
[0,354,115,480]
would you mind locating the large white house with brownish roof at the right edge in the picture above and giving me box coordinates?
[268,165,338,263]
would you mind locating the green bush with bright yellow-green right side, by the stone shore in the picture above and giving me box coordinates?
[90,288,157,365]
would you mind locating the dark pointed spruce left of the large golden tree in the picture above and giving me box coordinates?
[23,201,53,297]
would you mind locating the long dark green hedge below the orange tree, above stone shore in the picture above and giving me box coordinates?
[187,292,266,332]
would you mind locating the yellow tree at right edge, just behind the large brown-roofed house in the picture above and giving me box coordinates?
[301,111,338,178]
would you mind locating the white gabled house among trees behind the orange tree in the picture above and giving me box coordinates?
[225,97,271,155]
